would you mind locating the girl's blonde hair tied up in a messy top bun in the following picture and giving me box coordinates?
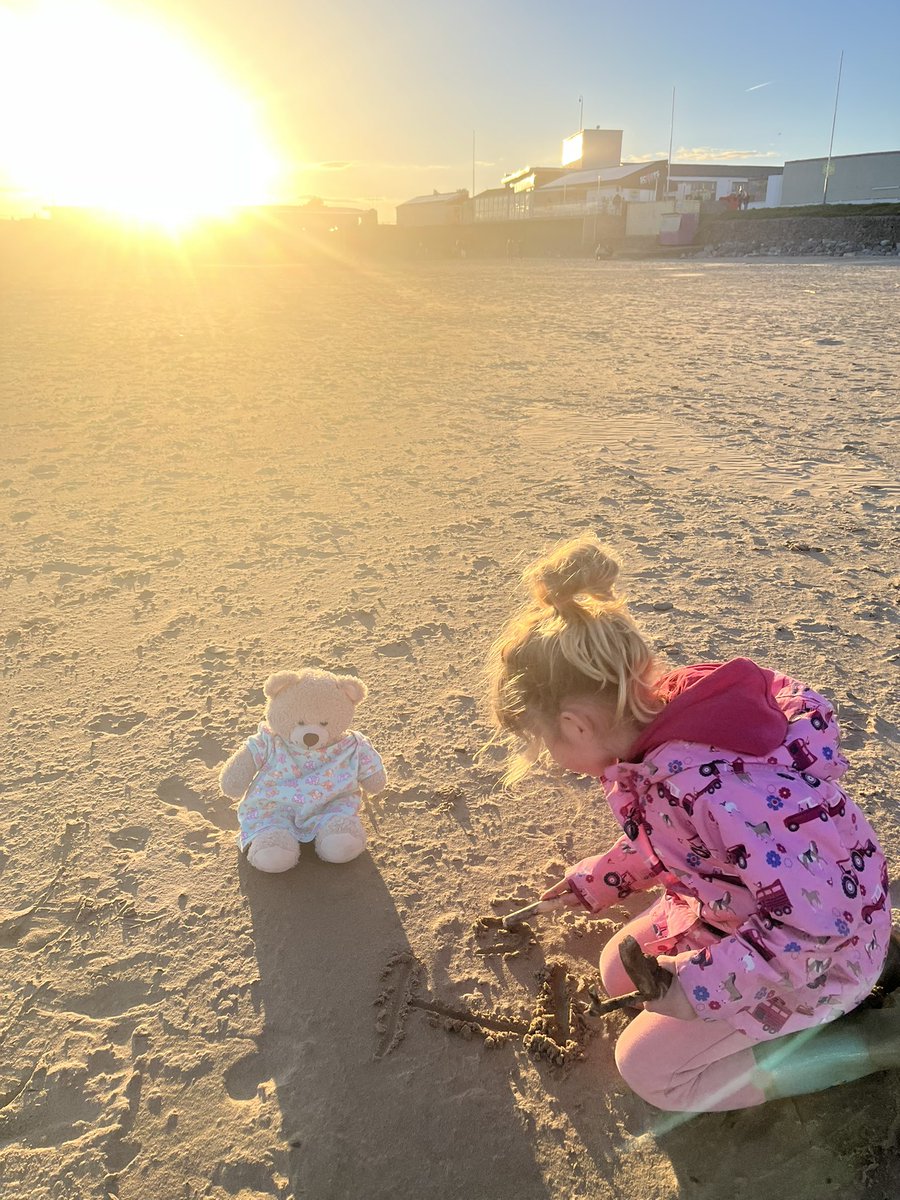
[487,534,662,784]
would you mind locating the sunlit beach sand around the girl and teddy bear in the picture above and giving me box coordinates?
[0,246,900,1200]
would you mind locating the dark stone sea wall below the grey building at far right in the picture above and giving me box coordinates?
[695,215,900,257]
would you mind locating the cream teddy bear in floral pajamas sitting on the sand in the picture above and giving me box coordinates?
[218,668,388,871]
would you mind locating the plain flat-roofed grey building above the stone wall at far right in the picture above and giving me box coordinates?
[781,150,900,205]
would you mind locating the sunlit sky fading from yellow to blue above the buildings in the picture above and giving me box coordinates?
[0,0,900,221]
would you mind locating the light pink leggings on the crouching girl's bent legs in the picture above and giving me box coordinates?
[600,906,766,1112]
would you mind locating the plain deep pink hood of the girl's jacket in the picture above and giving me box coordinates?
[628,659,787,762]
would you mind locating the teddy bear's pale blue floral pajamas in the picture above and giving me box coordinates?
[238,722,383,850]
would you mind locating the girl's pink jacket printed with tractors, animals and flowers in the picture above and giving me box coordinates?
[566,659,890,1042]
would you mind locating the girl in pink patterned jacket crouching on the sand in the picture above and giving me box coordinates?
[490,536,900,1112]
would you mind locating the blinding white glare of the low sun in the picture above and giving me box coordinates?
[0,0,280,229]
